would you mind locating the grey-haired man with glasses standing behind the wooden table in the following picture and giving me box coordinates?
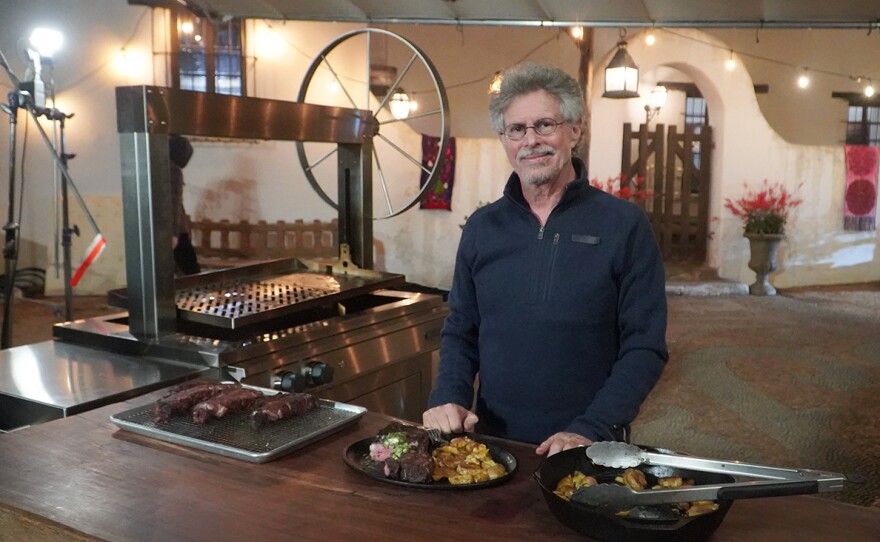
[423,64,668,455]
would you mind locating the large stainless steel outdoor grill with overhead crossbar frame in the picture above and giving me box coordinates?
[54,86,447,420]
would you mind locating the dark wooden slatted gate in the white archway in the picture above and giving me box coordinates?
[621,123,712,263]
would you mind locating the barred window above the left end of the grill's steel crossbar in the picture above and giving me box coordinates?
[170,12,246,96]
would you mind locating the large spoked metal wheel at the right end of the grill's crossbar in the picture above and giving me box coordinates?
[296,28,449,219]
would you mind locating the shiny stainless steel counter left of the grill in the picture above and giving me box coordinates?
[0,341,207,431]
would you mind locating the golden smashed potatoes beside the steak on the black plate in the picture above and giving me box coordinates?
[431,437,507,485]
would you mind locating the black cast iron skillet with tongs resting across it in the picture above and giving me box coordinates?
[534,447,736,542]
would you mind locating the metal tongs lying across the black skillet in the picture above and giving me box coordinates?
[571,441,847,509]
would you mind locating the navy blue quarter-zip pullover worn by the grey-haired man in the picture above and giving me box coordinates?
[429,159,669,444]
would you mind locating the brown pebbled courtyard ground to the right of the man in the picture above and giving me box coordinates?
[633,291,880,506]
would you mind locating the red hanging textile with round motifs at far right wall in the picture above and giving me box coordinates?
[843,145,878,231]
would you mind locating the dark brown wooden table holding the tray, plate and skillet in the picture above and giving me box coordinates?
[0,393,880,542]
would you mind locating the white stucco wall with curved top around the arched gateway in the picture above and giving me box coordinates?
[590,29,880,294]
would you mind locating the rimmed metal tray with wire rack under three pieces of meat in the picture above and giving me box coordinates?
[110,388,367,463]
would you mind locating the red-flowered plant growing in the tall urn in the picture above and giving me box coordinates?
[724,179,803,235]
